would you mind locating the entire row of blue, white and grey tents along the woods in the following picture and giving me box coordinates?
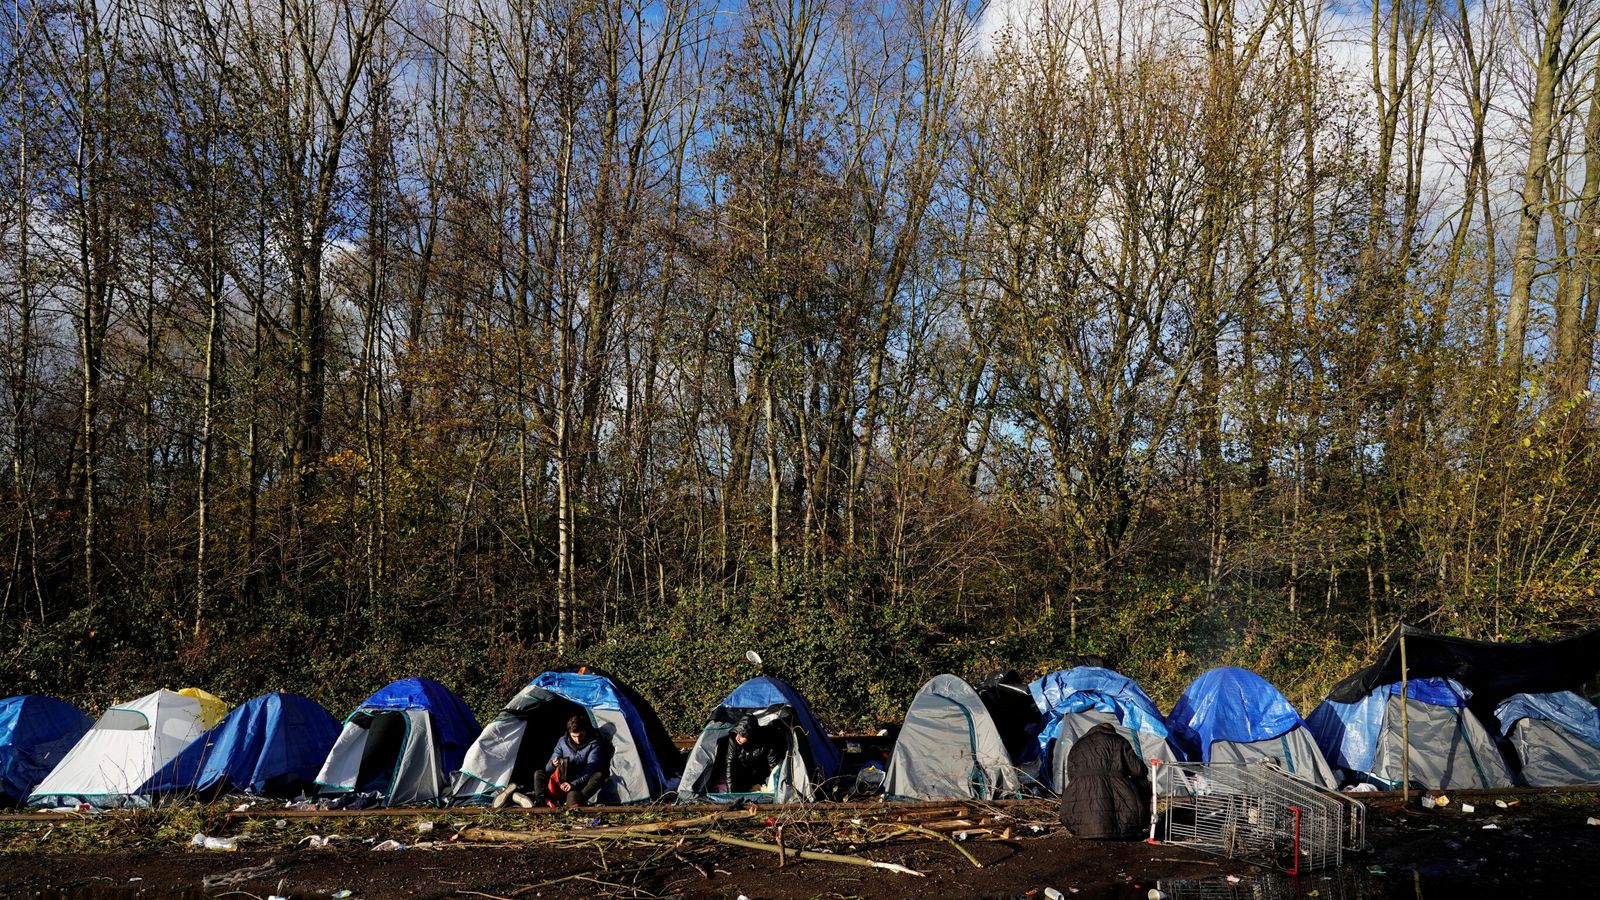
[0,626,1600,807]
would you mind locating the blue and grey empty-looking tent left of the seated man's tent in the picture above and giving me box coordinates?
[317,677,478,806]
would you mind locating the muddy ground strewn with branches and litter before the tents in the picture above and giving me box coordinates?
[0,794,1600,900]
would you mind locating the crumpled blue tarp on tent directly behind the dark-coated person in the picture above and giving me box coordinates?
[1027,666,1174,791]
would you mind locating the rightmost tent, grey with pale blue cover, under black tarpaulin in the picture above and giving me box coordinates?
[1494,690,1600,788]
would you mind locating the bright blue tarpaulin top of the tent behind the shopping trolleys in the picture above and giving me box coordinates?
[1166,666,1306,762]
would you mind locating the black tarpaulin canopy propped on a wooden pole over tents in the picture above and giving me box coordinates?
[1328,623,1600,709]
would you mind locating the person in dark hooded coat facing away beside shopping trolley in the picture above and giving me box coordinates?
[1061,722,1150,841]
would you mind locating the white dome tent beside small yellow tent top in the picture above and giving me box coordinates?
[27,690,227,809]
